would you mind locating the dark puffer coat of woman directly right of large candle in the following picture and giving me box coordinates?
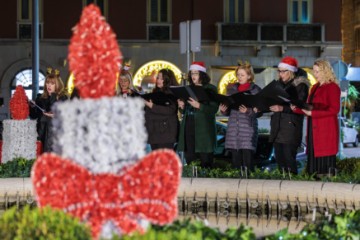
[145,95,179,144]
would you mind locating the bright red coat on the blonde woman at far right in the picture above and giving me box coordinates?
[296,82,340,157]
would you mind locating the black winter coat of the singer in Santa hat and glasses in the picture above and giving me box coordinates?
[269,77,309,145]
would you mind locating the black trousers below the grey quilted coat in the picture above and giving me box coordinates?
[231,149,254,171]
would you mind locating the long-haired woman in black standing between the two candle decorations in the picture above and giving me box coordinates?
[30,68,68,152]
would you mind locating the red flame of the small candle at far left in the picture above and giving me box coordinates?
[10,85,29,120]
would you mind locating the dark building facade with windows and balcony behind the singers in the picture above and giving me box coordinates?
[0,0,344,120]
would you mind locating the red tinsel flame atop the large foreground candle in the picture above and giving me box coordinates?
[69,4,122,98]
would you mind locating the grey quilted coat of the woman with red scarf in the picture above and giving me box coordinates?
[225,83,261,151]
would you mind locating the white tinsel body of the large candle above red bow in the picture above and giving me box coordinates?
[52,97,147,173]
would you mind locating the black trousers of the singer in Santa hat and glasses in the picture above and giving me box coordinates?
[274,143,298,174]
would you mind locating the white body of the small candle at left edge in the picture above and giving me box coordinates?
[1,119,37,163]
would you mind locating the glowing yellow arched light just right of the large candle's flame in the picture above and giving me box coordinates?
[133,60,181,86]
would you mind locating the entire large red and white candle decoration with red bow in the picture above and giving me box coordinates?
[32,4,181,238]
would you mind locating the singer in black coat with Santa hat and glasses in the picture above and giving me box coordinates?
[269,57,310,174]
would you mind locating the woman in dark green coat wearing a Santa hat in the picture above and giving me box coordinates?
[177,62,219,167]
